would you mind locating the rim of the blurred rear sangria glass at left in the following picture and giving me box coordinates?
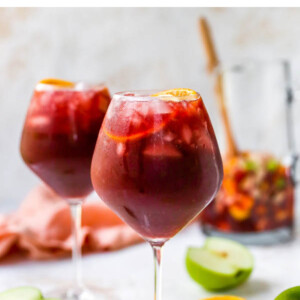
[34,80,107,92]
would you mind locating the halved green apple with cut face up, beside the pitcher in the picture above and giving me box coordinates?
[186,237,253,291]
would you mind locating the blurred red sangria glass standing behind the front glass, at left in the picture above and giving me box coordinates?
[20,79,110,299]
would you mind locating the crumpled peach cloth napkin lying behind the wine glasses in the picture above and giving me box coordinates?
[0,185,142,259]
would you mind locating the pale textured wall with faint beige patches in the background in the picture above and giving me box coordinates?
[0,8,300,207]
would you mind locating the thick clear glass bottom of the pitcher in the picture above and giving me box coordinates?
[201,224,294,246]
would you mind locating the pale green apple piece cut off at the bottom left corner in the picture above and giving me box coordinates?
[0,287,43,300]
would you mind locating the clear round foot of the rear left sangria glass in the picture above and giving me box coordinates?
[47,288,117,300]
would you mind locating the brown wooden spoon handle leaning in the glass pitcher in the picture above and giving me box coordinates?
[199,18,239,157]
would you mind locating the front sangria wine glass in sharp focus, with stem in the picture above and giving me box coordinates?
[91,89,223,300]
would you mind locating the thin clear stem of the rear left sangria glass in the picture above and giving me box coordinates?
[69,200,83,290]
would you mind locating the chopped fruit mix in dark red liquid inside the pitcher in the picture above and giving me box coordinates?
[201,152,294,232]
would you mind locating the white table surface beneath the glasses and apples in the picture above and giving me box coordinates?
[0,224,300,300]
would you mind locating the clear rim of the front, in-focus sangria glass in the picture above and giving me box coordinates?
[112,89,202,102]
